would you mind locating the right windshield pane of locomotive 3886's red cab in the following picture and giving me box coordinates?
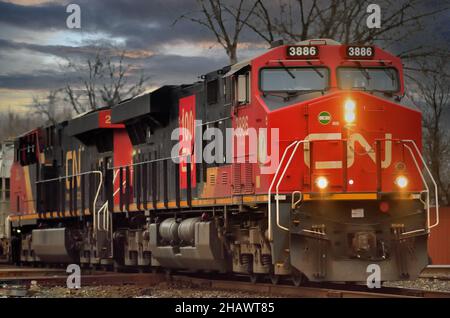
[337,67,399,92]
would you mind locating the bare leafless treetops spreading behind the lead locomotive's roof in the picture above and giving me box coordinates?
[181,0,450,62]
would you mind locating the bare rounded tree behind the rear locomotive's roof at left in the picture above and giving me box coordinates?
[65,49,148,114]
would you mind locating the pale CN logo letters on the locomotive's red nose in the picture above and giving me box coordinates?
[304,133,392,169]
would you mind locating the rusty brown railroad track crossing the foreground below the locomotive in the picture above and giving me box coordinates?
[0,267,450,298]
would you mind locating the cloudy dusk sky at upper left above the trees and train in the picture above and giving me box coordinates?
[0,0,265,112]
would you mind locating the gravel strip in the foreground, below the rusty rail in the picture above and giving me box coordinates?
[28,282,272,298]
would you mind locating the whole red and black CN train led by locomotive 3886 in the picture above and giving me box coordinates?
[3,39,436,284]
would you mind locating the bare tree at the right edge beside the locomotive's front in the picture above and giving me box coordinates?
[408,59,450,205]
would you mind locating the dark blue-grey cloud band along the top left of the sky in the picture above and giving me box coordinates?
[0,0,250,48]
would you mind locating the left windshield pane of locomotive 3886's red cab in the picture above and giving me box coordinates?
[260,67,328,92]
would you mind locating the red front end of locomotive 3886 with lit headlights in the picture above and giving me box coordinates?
[237,40,437,281]
